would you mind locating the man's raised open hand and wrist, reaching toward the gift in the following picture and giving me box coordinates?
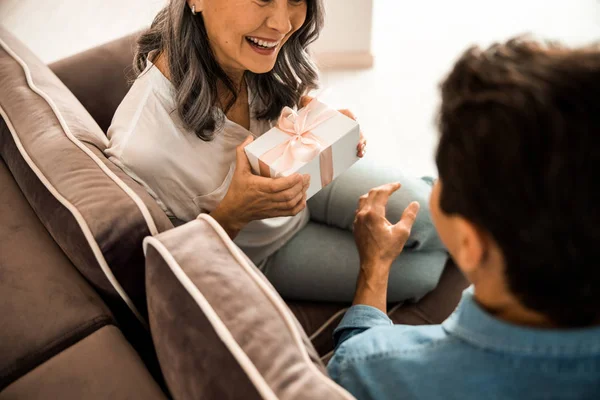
[354,183,419,312]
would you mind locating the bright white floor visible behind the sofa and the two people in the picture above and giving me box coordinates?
[0,0,600,175]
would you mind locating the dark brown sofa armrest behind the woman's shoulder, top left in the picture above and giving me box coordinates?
[50,33,139,132]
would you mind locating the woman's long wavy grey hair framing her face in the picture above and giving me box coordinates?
[133,0,323,141]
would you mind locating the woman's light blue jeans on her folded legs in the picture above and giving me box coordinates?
[263,160,448,302]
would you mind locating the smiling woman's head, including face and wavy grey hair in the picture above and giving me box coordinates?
[135,0,323,140]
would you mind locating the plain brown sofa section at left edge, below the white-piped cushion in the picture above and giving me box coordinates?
[0,158,114,390]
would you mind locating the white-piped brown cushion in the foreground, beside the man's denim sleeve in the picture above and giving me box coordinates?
[144,215,352,400]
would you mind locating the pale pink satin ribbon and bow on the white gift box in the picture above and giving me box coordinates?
[258,99,337,187]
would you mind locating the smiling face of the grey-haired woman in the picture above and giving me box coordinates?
[193,0,307,74]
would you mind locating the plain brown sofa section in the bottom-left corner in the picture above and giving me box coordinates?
[0,326,166,400]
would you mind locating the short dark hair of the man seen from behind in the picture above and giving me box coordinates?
[436,38,600,326]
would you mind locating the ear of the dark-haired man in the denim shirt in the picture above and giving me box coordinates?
[453,217,489,282]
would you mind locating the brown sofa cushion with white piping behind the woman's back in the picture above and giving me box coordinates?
[0,28,172,321]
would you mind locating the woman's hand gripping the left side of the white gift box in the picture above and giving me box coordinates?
[210,136,310,239]
